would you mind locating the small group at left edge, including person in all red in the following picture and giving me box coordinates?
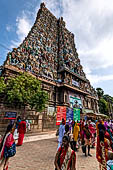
[0,116,26,170]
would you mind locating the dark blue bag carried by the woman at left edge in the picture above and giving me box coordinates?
[4,142,16,158]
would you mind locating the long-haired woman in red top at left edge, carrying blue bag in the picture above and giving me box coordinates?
[0,124,16,170]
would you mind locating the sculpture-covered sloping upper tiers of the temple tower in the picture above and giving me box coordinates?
[4,3,96,98]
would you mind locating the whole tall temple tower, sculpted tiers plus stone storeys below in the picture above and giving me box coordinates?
[0,3,98,128]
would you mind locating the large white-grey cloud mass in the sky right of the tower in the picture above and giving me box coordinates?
[60,0,113,70]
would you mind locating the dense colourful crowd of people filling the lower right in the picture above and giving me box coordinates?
[55,119,113,170]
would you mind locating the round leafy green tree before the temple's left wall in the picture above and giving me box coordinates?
[2,73,48,114]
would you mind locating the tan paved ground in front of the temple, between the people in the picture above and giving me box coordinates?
[8,132,98,170]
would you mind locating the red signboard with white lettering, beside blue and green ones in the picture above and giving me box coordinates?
[56,106,66,125]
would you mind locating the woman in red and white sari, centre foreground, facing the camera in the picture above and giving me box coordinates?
[54,135,76,170]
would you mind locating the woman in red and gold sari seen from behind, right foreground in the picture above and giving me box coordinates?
[96,129,110,170]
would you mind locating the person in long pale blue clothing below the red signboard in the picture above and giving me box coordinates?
[57,119,65,150]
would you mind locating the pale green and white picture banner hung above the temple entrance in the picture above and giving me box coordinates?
[69,96,82,108]
